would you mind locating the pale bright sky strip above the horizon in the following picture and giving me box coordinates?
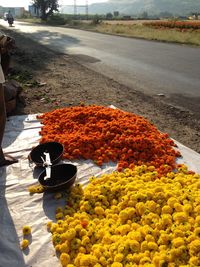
[0,0,106,9]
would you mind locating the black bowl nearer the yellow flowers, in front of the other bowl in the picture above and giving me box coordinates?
[38,164,77,191]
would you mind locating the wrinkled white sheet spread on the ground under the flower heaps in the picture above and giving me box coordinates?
[0,115,200,267]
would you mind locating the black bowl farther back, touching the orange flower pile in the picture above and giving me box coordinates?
[29,142,64,166]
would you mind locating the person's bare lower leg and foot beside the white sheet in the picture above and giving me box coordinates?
[0,84,17,167]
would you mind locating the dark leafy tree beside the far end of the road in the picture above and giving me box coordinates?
[33,0,58,20]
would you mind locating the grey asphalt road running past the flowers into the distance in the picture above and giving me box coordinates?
[0,20,200,99]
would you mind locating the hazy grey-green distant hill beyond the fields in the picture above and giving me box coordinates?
[63,0,200,15]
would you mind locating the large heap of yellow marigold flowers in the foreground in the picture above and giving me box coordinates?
[47,165,200,267]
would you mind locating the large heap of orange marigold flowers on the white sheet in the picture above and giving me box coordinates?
[39,105,180,174]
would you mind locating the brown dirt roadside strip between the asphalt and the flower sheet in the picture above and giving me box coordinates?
[1,26,200,153]
